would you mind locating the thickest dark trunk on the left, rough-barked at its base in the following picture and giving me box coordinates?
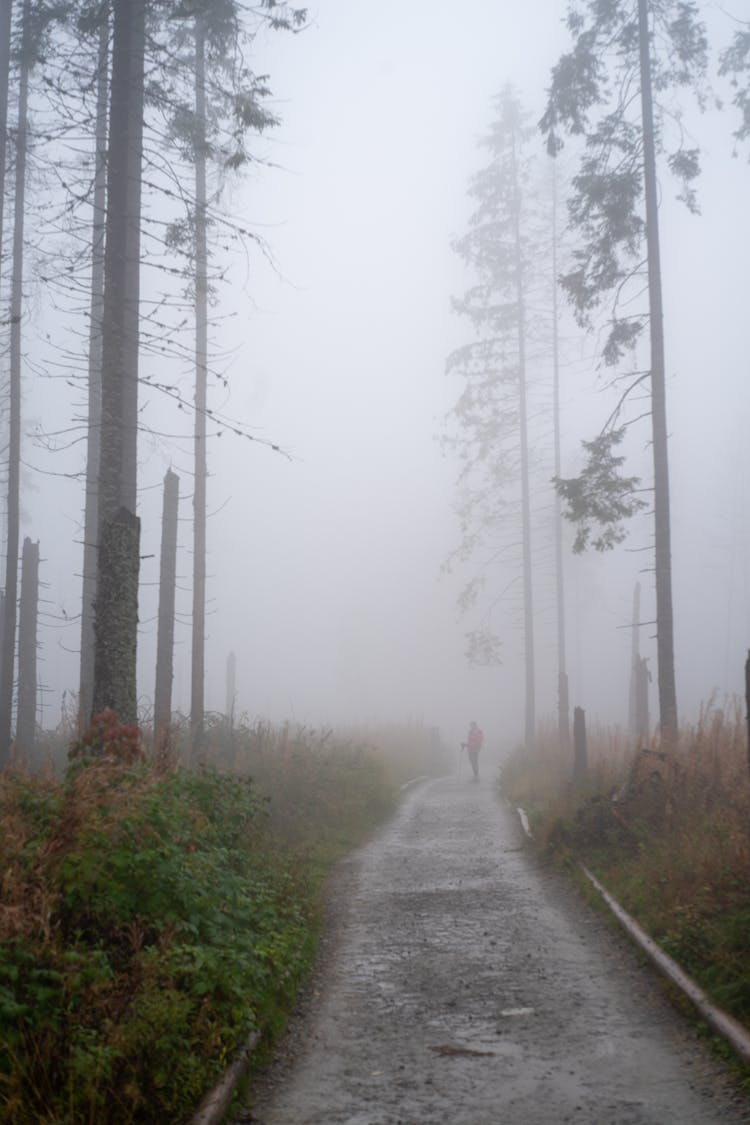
[92,0,145,722]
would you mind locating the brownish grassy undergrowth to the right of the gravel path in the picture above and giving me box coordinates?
[501,704,750,1027]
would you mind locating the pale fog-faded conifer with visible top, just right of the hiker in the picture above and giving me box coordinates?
[448,87,546,747]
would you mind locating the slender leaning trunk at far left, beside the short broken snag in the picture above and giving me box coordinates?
[0,0,30,766]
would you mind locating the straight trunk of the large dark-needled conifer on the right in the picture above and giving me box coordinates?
[638,0,677,743]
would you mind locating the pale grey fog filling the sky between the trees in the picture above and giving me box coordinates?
[13,0,750,746]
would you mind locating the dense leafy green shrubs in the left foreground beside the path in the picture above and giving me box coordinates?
[0,757,310,1125]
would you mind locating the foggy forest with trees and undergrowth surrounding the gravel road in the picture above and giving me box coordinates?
[0,0,750,1123]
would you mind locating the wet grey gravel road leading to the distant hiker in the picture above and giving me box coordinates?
[236,777,750,1125]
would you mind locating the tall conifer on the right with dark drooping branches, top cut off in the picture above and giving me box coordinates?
[541,0,707,740]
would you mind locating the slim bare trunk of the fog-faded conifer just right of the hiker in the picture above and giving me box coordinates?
[513,132,536,750]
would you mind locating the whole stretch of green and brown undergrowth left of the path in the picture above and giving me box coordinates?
[0,717,445,1125]
